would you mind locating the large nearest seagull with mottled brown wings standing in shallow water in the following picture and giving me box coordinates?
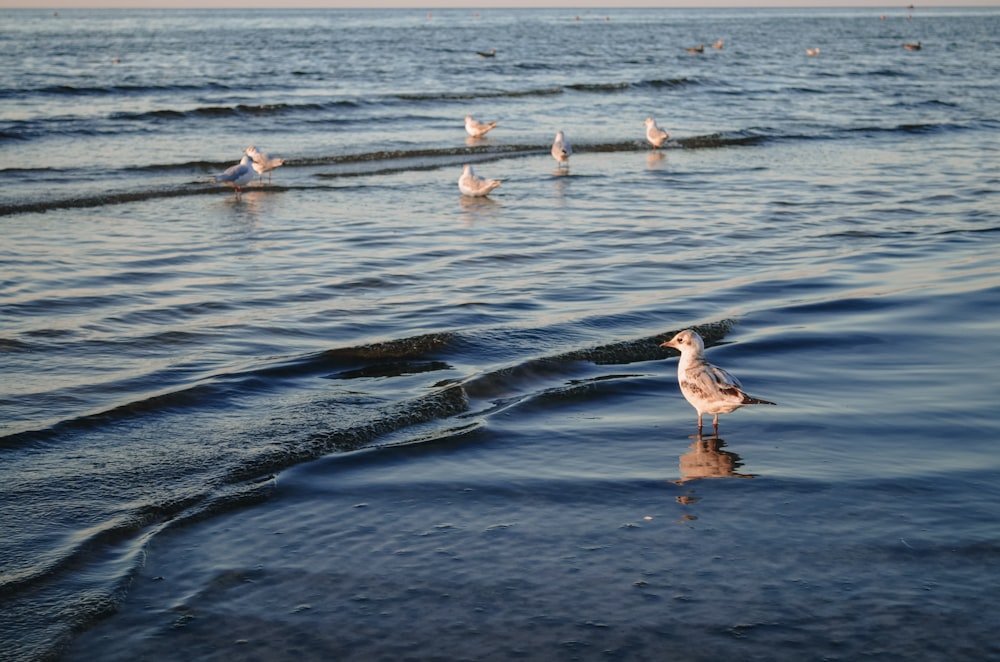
[660,329,774,434]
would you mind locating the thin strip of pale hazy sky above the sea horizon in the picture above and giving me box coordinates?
[7,0,1000,7]
